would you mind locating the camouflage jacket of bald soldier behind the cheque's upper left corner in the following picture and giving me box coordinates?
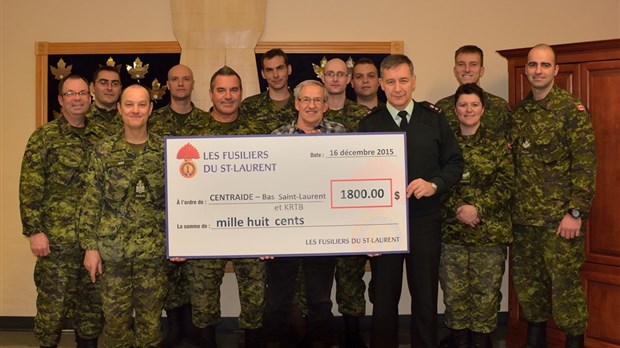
[149,104,207,137]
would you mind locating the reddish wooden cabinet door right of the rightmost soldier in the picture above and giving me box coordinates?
[581,60,620,347]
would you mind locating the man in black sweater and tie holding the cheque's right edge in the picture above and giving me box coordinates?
[359,55,464,348]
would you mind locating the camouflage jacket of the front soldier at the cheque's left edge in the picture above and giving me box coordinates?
[78,132,165,262]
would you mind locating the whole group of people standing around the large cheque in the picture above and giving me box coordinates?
[20,45,596,348]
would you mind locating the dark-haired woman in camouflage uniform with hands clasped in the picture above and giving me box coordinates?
[439,83,514,348]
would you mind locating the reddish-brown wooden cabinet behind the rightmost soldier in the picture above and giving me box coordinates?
[498,39,620,348]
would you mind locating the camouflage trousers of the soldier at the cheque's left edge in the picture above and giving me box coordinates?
[98,259,168,348]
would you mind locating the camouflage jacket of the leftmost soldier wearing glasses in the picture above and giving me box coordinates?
[19,117,105,247]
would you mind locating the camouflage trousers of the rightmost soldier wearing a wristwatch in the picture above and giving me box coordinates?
[511,225,588,335]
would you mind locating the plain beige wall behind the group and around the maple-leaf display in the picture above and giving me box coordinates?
[0,0,620,316]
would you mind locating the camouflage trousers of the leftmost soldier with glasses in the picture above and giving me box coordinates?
[34,246,103,346]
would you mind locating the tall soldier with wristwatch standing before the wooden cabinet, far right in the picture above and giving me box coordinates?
[509,44,596,347]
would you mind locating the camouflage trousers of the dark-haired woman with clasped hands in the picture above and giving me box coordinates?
[439,243,506,333]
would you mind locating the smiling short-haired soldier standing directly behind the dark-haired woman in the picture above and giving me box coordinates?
[435,45,512,137]
